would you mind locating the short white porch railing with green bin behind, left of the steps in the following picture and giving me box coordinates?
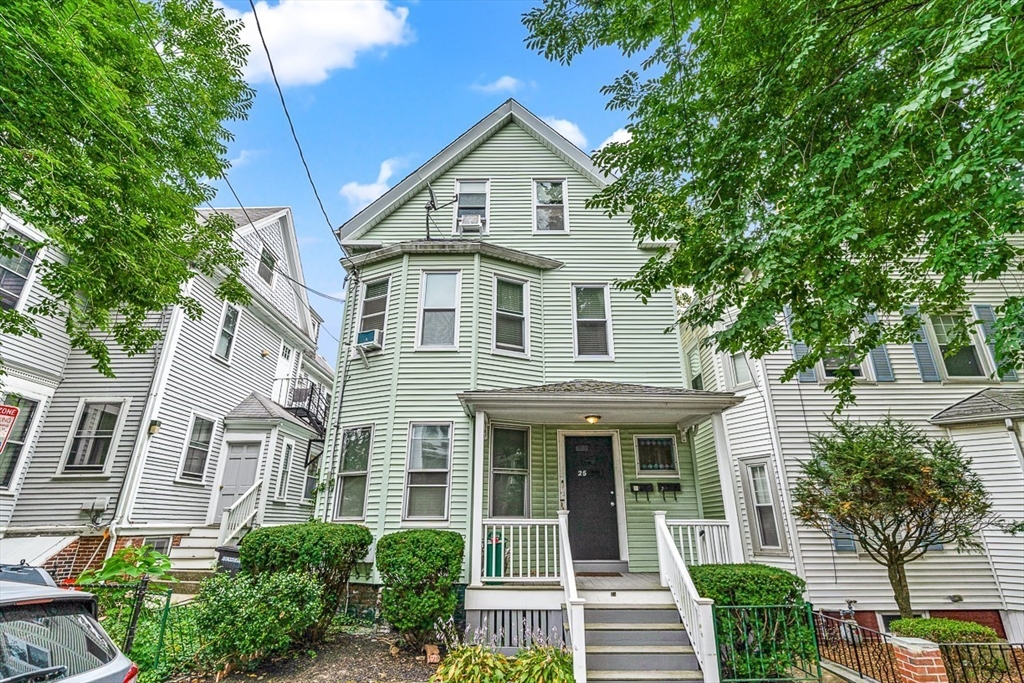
[480,519,561,584]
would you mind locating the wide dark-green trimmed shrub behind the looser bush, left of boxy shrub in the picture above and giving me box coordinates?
[239,521,374,640]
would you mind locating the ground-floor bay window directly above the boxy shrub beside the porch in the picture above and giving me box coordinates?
[404,423,452,520]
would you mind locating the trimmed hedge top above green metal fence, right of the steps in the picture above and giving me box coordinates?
[687,564,807,605]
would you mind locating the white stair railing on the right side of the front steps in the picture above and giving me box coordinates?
[654,512,721,683]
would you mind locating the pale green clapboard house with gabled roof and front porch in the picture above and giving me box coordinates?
[318,100,741,681]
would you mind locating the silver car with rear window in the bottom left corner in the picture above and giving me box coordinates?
[0,579,138,683]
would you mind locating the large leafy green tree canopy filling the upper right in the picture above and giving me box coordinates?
[524,0,1024,408]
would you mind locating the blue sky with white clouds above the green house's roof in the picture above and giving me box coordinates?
[214,0,629,365]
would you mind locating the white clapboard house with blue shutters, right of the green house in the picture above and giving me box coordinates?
[683,294,1024,642]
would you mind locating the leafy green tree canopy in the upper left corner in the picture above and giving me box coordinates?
[0,0,253,376]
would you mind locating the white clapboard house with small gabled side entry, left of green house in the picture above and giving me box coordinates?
[0,207,333,575]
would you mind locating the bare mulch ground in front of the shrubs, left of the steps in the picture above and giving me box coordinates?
[188,634,436,683]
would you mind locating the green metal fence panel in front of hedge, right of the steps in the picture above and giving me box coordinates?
[713,604,821,683]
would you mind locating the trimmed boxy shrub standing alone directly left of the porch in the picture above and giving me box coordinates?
[377,529,466,649]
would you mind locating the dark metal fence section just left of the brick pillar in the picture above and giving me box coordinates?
[814,612,900,683]
